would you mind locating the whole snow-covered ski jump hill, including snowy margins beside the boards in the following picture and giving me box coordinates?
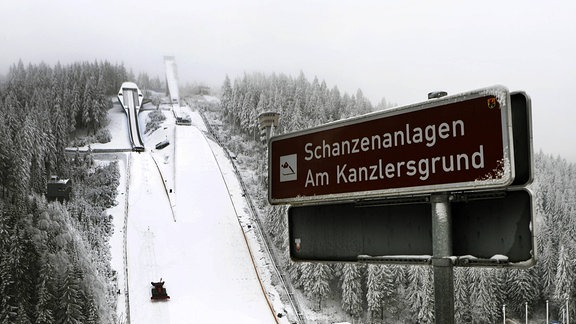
[96,102,289,323]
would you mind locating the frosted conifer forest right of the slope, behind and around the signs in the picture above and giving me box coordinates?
[213,73,576,323]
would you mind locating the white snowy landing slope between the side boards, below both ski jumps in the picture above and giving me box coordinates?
[127,120,276,324]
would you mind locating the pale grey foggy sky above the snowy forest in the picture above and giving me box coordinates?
[0,0,576,162]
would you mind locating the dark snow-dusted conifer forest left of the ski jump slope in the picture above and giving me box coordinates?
[0,61,129,324]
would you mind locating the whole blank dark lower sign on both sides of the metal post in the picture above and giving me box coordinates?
[288,190,535,266]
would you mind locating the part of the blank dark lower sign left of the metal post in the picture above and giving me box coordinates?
[288,199,432,261]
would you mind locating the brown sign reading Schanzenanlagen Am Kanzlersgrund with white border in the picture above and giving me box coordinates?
[268,86,514,204]
